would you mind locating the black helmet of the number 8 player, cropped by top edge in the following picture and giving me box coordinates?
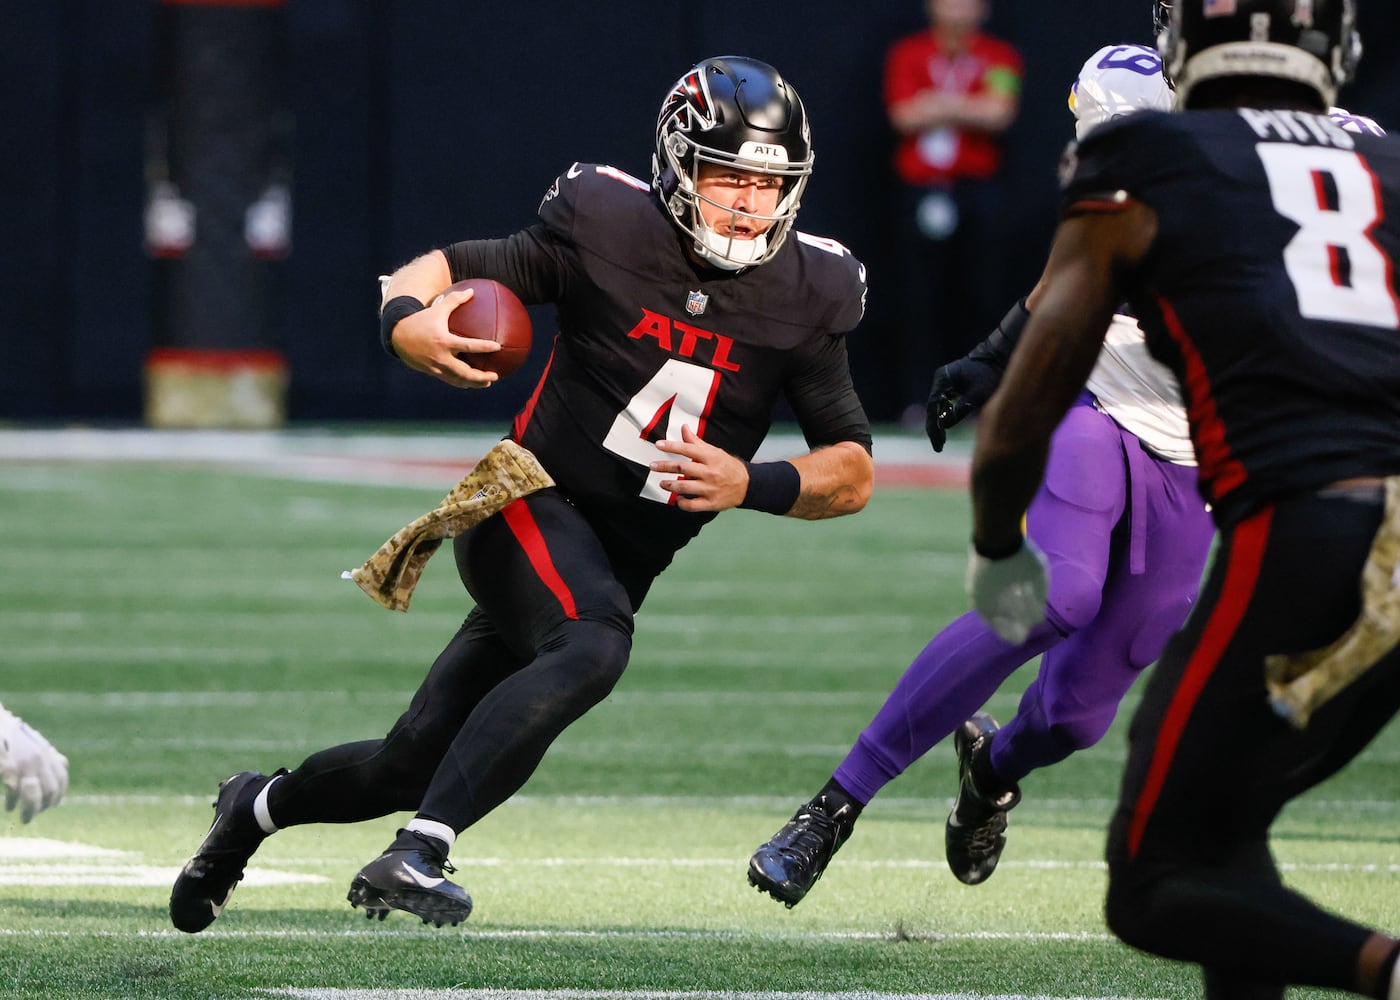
[1154,0,1361,106]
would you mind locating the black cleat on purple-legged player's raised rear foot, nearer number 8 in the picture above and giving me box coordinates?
[944,711,1021,885]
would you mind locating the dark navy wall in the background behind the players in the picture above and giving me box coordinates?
[8,0,1400,422]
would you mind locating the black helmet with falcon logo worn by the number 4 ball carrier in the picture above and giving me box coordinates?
[651,56,813,270]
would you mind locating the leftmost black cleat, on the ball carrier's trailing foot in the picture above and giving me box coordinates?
[171,770,278,934]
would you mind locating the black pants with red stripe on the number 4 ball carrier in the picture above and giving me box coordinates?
[269,489,641,832]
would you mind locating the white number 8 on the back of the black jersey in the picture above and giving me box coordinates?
[1256,143,1400,329]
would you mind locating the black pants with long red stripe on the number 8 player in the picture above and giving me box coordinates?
[1107,481,1400,1000]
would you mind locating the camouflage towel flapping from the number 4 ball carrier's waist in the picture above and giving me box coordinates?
[340,440,554,611]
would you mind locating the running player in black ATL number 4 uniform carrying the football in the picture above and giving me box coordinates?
[171,56,874,931]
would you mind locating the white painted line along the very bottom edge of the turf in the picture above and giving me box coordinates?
[258,986,1153,1000]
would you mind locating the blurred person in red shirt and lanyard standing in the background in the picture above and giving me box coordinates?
[885,0,1022,427]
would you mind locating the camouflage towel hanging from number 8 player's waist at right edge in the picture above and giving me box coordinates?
[1264,476,1400,728]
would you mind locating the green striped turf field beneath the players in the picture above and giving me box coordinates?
[0,436,1400,1000]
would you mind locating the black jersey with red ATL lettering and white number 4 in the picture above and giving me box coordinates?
[444,164,871,569]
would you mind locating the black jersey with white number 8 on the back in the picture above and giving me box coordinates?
[1064,109,1400,524]
